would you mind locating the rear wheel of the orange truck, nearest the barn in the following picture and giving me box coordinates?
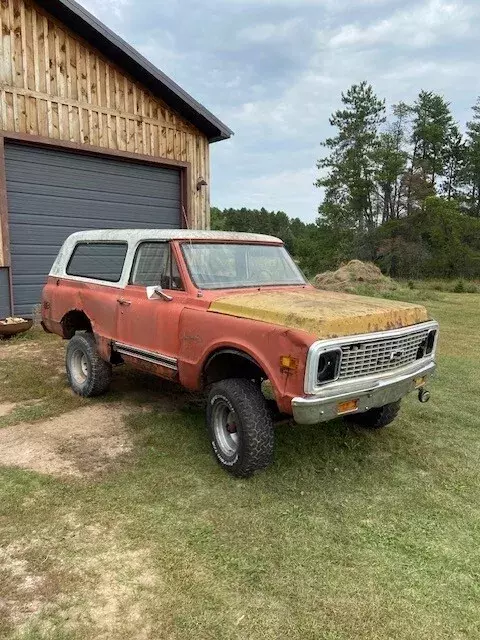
[66,331,112,397]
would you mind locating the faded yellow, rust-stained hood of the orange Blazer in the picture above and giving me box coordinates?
[209,288,429,339]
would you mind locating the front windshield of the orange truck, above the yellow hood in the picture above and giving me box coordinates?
[182,243,305,289]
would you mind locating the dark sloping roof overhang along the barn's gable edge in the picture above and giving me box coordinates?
[36,0,233,142]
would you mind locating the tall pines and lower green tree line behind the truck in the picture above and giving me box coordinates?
[212,82,480,278]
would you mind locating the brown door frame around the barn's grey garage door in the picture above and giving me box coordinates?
[0,131,192,315]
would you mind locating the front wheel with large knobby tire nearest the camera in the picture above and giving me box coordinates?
[207,378,274,478]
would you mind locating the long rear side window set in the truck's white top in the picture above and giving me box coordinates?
[67,242,127,282]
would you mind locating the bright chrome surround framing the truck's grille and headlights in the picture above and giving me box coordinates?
[304,320,439,395]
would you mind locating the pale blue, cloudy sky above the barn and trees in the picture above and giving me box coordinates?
[80,0,480,222]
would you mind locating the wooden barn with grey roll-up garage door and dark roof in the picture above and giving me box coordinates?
[0,0,232,318]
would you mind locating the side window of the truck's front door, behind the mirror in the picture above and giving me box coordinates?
[130,242,183,291]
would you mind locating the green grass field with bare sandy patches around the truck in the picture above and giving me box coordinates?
[0,293,480,640]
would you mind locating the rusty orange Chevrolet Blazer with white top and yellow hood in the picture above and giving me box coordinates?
[42,230,438,477]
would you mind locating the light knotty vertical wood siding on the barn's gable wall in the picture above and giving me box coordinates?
[0,0,210,264]
